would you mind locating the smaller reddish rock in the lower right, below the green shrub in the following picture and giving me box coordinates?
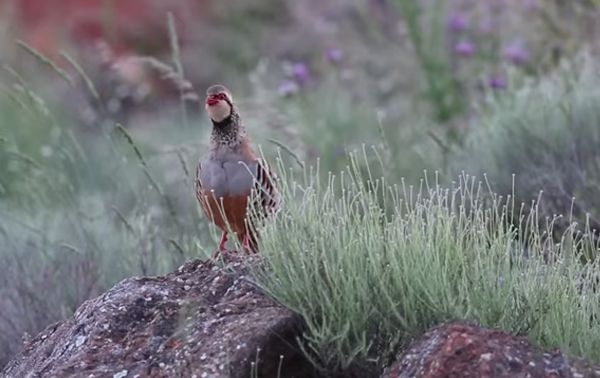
[383,323,600,378]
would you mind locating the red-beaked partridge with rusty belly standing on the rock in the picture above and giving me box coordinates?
[195,84,281,258]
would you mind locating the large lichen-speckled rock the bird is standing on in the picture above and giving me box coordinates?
[3,261,313,378]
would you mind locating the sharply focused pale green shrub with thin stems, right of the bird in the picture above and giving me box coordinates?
[256,157,600,376]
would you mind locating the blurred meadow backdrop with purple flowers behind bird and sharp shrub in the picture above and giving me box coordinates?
[0,0,600,366]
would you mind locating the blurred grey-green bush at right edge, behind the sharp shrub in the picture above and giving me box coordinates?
[454,56,600,244]
